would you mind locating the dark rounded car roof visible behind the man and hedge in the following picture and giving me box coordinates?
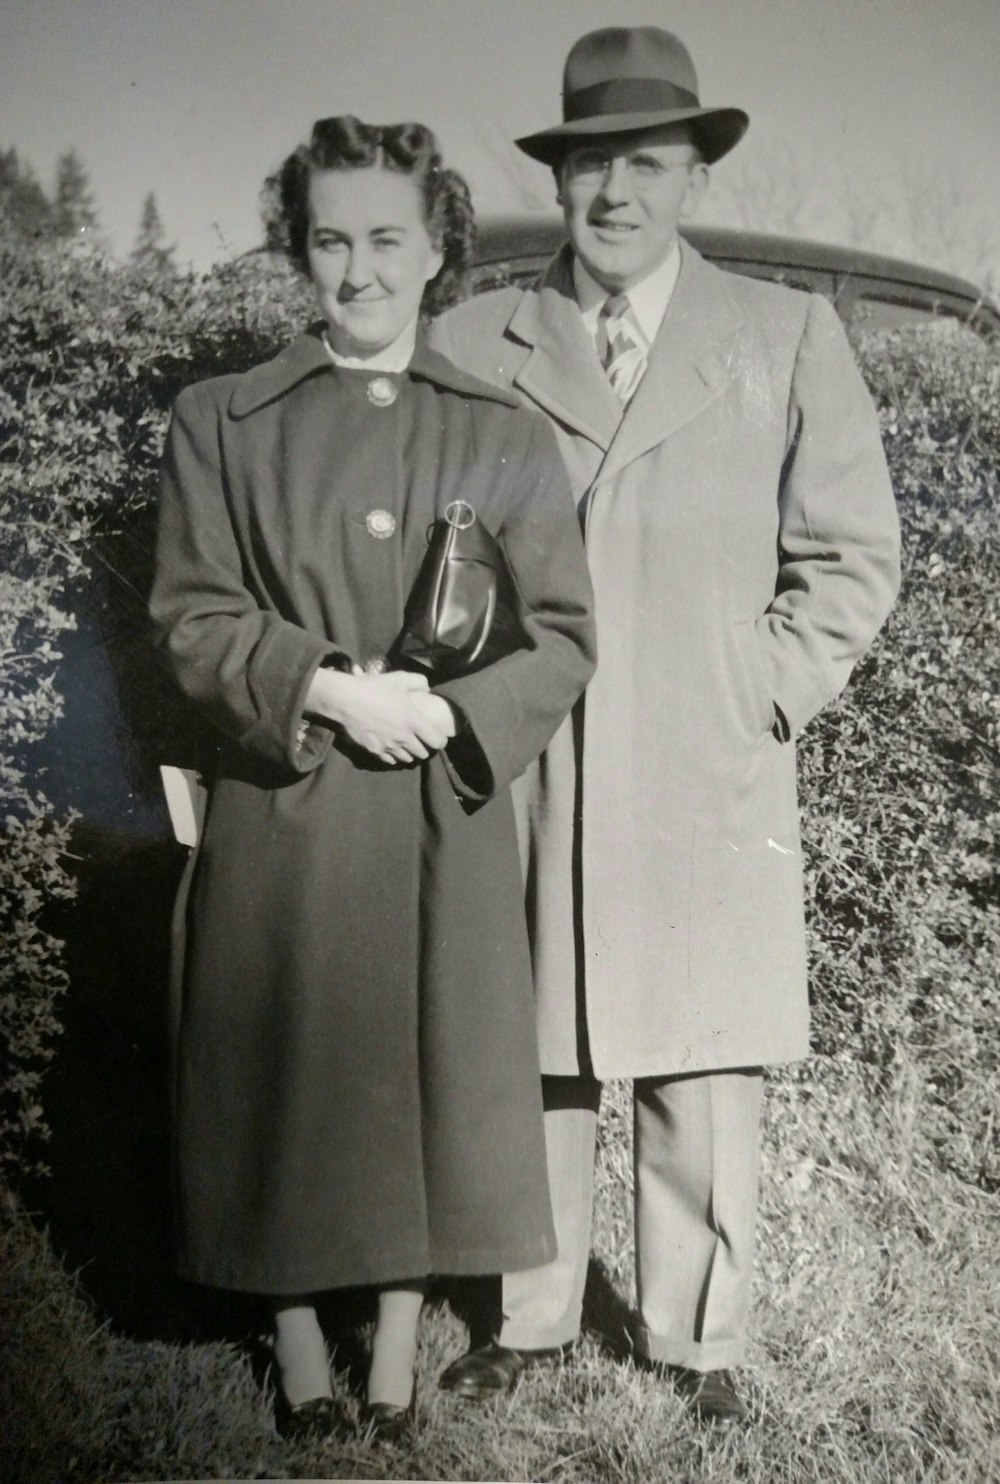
[475,215,1000,337]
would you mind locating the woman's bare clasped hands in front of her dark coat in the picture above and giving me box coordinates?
[306,665,457,764]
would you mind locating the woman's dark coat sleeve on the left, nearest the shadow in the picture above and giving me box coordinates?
[150,386,350,773]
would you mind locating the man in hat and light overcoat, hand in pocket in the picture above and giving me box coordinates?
[427,27,899,1422]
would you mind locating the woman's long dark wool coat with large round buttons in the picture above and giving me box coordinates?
[151,332,593,1293]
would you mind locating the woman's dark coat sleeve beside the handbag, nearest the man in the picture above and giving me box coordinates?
[435,411,596,798]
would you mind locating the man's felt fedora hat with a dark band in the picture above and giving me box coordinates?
[515,25,749,165]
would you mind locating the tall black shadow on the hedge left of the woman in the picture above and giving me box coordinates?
[21,505,241,1339]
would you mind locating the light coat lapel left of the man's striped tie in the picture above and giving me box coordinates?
[507,249,622,450]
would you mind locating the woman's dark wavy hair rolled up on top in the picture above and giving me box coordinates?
[263,113,476,318]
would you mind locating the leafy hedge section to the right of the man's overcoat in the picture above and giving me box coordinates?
[800,324,1000,1189]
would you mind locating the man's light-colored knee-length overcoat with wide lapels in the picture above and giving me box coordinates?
[436,245,899,1077]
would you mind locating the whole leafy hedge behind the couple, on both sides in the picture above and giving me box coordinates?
[0,245,1000,1187]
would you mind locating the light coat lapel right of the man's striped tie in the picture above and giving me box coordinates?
[601,243,740,479]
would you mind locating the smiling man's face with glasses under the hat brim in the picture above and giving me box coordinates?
[558,125,708,294]
